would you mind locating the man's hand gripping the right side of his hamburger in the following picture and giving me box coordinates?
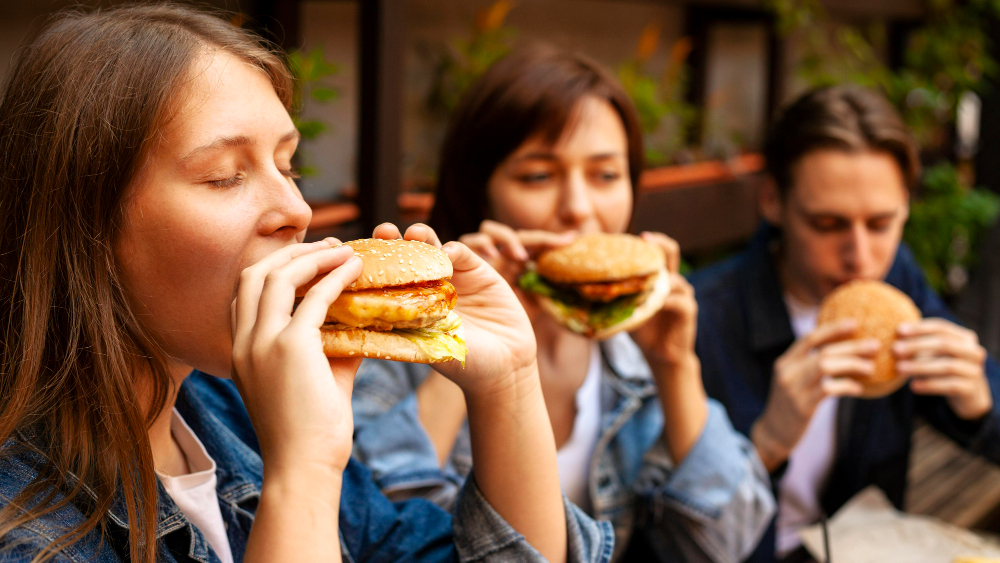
[892,319,993,420]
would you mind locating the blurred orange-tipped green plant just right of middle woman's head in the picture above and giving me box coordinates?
[618,23,698,166]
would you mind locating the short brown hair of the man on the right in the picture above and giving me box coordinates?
[764,86,920,196]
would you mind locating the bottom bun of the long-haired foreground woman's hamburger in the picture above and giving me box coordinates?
[320,328,462,364]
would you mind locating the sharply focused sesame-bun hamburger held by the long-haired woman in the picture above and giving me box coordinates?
[299,239,467,364]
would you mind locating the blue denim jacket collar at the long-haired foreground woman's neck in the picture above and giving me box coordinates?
[109,372,264,539]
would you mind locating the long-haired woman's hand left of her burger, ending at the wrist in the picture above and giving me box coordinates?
[233,239,361,473]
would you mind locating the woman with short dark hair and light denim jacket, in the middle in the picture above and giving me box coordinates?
[354,46,774,562]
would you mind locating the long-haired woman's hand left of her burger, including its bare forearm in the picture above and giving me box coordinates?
[232,239,361,563]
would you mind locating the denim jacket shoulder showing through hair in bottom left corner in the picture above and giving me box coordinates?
[0,440,115,563]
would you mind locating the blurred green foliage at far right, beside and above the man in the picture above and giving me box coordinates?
[766,0,1000,295]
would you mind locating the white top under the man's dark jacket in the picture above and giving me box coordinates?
[775,295,837,558]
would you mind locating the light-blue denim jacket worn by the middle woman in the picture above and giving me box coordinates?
[353,334,774,562]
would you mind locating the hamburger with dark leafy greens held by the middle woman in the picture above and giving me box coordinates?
[518,233,670,339]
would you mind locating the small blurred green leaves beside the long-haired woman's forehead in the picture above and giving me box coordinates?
[288,47,340,176]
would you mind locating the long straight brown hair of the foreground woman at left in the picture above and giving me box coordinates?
[0,4,291,562]
